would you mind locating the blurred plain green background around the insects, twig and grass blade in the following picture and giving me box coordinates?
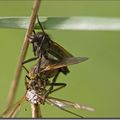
[0,0,120,118]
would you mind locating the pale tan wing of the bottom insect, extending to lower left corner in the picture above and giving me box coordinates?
[1,96,25,118]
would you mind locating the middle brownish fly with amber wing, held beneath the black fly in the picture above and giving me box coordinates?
[23,54,87,95]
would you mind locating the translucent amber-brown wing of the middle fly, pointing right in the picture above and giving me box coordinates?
[41,57,88,72]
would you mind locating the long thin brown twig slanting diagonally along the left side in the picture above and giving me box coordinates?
[3,0,41,115]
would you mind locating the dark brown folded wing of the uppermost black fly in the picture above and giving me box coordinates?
[49,41,73,59]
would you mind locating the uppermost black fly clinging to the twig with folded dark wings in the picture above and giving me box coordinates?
[23,16,78,75]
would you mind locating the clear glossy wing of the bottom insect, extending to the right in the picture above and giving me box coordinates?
[46,97,94,112]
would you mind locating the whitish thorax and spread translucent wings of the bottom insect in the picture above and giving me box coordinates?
[1,90,94,118]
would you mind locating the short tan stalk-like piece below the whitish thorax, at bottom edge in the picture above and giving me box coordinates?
[31,103,42,118]
